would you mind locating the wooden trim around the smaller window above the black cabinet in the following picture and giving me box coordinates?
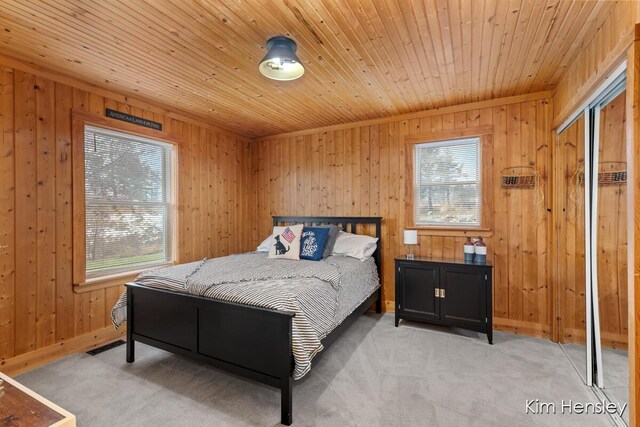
[404,125,493,235]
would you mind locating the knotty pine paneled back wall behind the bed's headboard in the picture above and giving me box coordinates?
[252,93,552,336]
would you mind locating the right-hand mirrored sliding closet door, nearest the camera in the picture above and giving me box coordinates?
[592,85,629,419]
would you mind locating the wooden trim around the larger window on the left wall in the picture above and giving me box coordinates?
[71,109,184,287]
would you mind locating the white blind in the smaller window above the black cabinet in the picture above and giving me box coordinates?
[414,138,481,227]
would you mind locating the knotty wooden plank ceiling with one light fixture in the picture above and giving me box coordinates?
[0,0,615,137]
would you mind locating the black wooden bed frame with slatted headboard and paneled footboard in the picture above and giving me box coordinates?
[126,216,382,425]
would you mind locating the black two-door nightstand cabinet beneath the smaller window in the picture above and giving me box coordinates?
[396,258,493,344]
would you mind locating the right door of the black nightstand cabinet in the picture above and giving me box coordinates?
[440,266,487,331]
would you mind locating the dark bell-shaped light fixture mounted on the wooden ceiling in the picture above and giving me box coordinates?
[258,36,304,81]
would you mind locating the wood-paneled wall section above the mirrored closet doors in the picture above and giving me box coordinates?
[553,1,640,125]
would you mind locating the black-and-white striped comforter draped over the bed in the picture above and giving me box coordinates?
[111,253,350,379]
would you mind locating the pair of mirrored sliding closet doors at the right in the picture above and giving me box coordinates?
[557,65,629,424]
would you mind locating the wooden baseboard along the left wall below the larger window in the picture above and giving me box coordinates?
[0,326,126,376]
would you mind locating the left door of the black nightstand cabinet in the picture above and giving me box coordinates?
[396,264,440,320]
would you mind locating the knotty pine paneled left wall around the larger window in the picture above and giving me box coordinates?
[0,66,253,372]
